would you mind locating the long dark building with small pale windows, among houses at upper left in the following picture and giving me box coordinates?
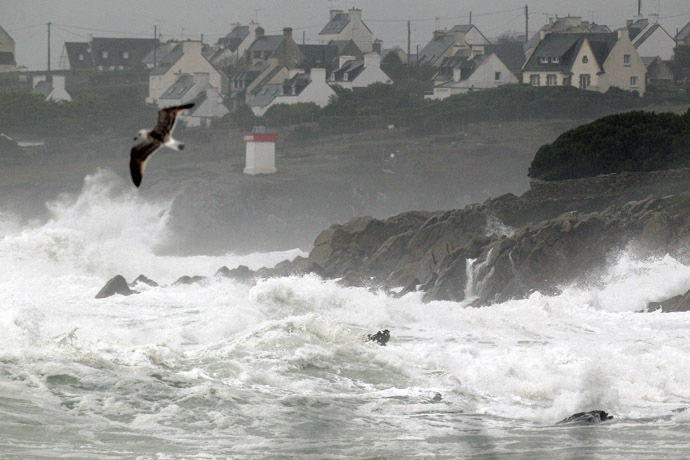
[59,37,158,72]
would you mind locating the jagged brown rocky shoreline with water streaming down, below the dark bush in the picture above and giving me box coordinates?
[97,170,690,311]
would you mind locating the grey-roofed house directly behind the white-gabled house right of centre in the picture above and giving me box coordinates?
[417,24,491,67]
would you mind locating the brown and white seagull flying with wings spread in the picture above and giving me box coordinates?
[129,103,194,187]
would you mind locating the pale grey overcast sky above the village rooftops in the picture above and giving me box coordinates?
[0,0,690,69]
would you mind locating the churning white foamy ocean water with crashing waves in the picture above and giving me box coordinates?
[0,171,690,460]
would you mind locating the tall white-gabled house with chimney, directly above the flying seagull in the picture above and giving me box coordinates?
[146,40,223,104]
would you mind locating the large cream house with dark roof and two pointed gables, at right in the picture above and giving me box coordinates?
[522,29,647,95]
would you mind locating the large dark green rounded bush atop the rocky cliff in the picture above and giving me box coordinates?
[528,110,690,181]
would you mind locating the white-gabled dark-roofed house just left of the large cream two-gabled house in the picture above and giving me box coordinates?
[426,53,519,99]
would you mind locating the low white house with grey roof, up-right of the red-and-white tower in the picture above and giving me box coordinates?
[249,68,335,117]
